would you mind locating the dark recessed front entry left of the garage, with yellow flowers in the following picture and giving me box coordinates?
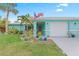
[37,22,45,40]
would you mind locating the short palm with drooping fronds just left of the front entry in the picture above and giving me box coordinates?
[18,14,33,31]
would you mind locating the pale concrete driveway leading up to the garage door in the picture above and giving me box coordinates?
[52,38,79,56]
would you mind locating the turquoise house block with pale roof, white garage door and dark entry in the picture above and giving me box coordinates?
[32,17,79,38]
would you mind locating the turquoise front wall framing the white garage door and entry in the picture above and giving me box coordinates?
[34,20,79,37]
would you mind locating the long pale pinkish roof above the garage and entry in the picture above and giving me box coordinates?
[32,17,79,20]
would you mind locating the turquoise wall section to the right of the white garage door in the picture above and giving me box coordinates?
[69,21,79,38]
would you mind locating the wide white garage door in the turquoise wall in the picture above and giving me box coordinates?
[48,22,68,37]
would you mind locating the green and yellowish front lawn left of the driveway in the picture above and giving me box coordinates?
[0,34,64,56]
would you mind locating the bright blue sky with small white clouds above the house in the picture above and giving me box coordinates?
[0,3,79,20]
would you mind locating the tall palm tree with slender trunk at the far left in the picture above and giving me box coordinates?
[0,3,18,33]
